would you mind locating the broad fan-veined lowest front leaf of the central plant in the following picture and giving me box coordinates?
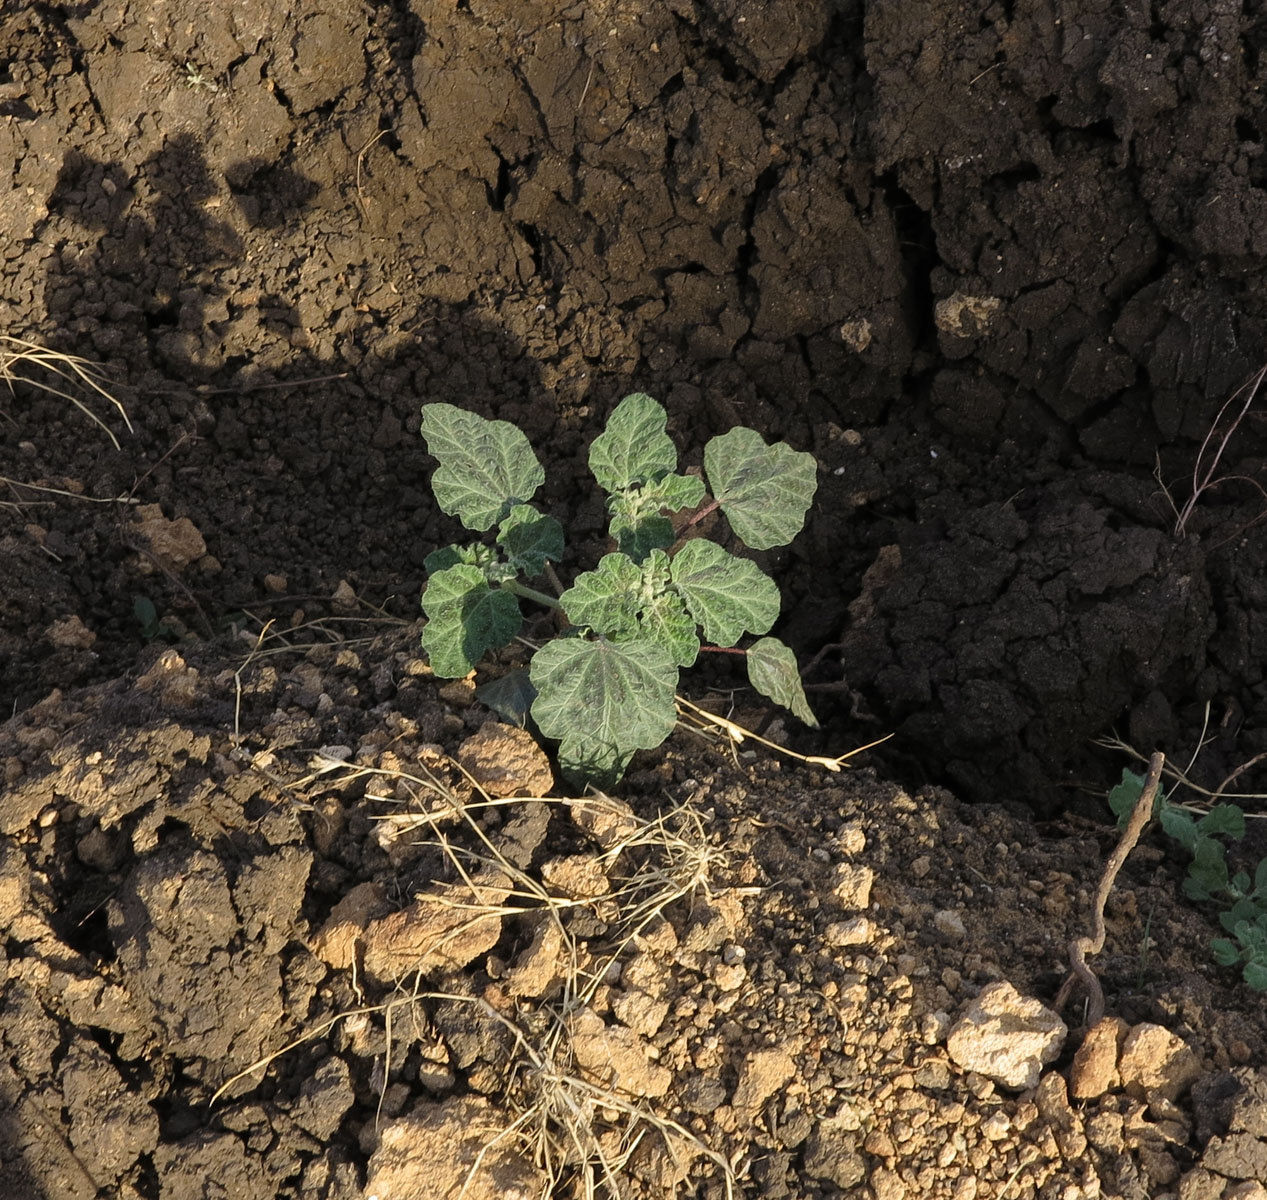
[531,637,678,784]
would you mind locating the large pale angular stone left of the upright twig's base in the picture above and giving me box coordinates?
[946,981,1068,1090]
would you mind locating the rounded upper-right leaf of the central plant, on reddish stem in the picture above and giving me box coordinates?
[704,426,818,550]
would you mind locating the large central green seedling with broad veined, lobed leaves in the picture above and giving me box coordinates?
[422,393,817,786]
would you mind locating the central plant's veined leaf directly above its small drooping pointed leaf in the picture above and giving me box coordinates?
[672,539,780,646]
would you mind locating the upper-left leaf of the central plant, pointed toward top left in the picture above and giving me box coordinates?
[422,404,546,531]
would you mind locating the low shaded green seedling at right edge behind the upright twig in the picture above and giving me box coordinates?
[1109,769,1267,992]
